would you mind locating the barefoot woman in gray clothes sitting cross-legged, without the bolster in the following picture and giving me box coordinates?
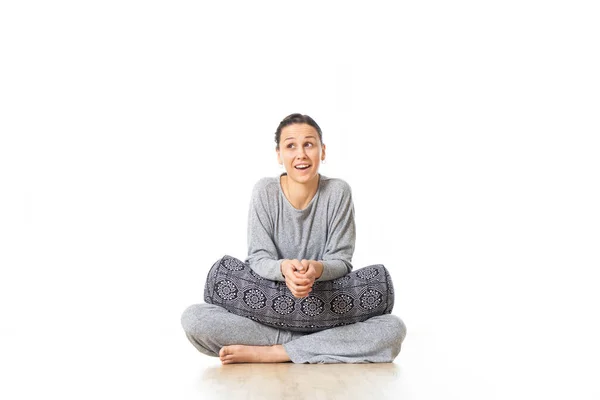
[182,114,406,364]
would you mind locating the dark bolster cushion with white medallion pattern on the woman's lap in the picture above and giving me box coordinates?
[204,256,394,332]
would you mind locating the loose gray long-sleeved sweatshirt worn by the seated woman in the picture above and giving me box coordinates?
[246,175,356,281]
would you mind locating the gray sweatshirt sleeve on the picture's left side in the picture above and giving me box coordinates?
[246,181,285,281]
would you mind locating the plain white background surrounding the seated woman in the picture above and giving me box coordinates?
[0,0,600,399]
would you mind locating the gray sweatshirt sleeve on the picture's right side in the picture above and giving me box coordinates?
[318,182,356,281]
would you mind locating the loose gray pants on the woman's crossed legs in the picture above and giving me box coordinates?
[181,304,406,364]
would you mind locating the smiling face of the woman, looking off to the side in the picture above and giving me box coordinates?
[277,124,325,183]
